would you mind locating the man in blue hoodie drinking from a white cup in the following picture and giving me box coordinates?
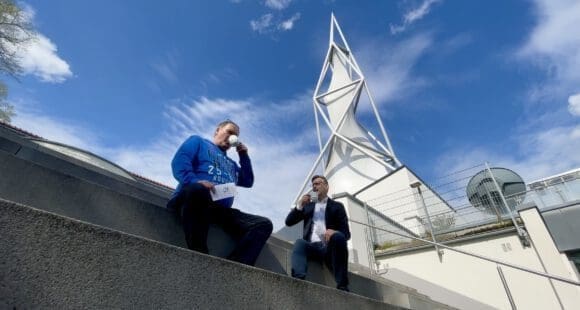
[167,120,273,266]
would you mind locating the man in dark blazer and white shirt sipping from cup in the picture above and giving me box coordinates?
[286,175,350,291]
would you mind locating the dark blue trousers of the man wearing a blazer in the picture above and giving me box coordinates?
[292,231,348,290]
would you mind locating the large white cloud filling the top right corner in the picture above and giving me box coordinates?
[517,0,580,99]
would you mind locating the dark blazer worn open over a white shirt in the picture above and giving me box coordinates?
[286,198,350,241]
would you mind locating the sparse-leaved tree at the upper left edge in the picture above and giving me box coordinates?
[0,0,33,122]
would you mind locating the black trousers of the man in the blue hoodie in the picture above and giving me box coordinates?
[170,183,273,266]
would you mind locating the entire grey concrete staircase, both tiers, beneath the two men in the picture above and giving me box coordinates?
[0,123,452,309]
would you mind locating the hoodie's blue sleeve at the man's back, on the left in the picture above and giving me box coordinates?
[171,136,201,185]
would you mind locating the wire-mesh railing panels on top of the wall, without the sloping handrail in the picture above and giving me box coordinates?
[365,164,580,249]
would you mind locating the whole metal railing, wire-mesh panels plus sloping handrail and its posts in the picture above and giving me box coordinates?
[350,164,580,309]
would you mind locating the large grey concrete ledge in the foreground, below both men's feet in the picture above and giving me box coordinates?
[0,200,402,310]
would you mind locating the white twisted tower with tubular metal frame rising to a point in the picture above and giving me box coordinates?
[295,14,401,201]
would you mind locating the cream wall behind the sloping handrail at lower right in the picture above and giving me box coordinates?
[377,209,580,309]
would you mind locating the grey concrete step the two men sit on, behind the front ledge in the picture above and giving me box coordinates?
[0,131,449,309]
